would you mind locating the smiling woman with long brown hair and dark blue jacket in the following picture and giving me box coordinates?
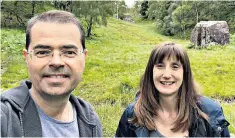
[116,43,229,137]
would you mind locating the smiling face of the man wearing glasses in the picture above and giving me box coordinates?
[24,22,86,96]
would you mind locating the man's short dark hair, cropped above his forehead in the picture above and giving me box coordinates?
[25,10,86,50]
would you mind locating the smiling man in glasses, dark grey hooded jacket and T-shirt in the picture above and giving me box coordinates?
[1,11,102,137]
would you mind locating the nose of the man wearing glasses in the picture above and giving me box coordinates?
[49,52,64,67]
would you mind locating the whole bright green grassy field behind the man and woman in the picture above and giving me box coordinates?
[1,19,235,136]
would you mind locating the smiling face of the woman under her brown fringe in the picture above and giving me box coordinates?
[153,57,184,95]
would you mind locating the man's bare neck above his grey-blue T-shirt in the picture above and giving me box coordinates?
[31,88,73,122]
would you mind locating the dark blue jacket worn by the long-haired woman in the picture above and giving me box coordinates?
[115,96,230,137]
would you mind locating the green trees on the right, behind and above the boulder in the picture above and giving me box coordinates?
[136,0,235,37]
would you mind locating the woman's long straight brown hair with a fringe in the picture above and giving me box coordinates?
[129,43,207,132]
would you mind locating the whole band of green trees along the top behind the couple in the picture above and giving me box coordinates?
[1,0,235,38]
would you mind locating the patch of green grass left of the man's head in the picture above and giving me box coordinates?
[1,29,27,91]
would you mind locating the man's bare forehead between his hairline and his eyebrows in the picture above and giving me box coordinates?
[28,22,82,48]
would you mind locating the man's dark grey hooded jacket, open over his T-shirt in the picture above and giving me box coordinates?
[1,81,102,137]
